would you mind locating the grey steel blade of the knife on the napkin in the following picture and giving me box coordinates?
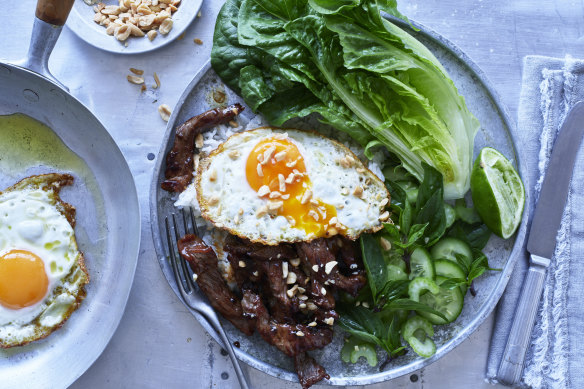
[527,101,584,259]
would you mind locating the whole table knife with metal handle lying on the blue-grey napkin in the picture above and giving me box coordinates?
[497,101,584,385]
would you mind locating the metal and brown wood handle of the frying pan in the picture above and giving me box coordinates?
[17,0,74,91]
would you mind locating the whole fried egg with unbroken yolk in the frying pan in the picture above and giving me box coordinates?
[0,174,89,348]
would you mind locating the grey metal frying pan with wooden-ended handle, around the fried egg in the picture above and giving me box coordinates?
[0,0,140,388]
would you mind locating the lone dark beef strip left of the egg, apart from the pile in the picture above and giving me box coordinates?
[160,104,244,192]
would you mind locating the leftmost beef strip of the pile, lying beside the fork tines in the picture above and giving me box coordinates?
[178,234,255,336]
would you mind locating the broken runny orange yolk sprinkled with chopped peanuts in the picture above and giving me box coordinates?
[246,137,346,237]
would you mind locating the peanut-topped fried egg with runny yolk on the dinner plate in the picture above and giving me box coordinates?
[195,127,389,245]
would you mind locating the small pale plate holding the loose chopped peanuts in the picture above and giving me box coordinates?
[66,0,203,54]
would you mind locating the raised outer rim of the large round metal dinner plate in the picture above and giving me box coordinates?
[150,15,531,386]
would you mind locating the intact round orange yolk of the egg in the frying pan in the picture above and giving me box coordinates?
[0,250,49,309]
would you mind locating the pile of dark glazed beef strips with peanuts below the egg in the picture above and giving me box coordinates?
[179,235,366,388]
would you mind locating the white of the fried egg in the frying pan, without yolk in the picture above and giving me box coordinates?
[0,175,88,347]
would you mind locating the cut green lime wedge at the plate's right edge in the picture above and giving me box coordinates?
[470,147,525,239]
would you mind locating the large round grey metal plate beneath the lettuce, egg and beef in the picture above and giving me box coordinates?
[150,17,528,386]
